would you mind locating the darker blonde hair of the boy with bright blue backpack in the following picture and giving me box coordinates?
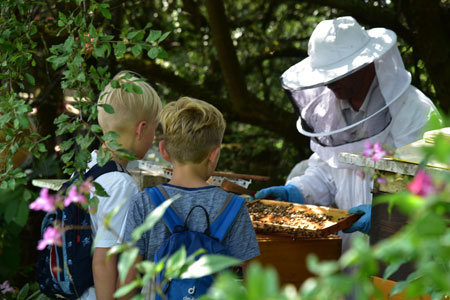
[160,97,226,164]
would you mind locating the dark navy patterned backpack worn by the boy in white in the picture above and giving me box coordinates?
[36,161,126,299]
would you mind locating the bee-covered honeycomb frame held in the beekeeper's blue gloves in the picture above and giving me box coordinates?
[247,199,360,237]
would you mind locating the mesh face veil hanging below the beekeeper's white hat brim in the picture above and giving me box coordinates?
[286,80,392,147]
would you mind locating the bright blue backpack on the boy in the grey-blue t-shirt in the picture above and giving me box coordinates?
[145,185,244,300]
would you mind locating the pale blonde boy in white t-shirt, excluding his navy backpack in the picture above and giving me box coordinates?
[81,71,162,299]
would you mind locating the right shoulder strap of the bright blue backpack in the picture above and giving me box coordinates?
[210,193,245,241]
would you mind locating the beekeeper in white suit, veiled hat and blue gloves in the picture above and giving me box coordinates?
[255,17,438,250]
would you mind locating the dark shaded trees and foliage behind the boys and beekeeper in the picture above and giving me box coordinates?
[3,0,450,288]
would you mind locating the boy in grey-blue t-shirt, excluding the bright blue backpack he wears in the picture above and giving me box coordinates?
[125,97,259,297]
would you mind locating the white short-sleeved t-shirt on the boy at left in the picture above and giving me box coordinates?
[81,151,139,300]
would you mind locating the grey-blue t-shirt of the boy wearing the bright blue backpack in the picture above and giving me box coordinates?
[125,183,259,261]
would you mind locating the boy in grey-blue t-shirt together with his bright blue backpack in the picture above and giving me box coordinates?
[125,97,259,299]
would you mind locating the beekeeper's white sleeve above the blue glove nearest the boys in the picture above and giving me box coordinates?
[286,153,336,206]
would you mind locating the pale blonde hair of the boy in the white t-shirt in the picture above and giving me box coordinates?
[98,71,162,133]
